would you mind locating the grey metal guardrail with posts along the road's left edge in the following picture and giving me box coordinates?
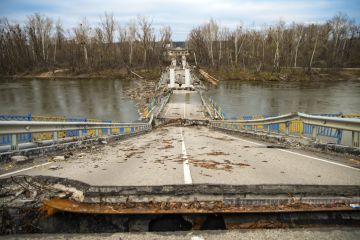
[0,115,153,151]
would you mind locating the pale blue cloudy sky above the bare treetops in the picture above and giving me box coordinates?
[0,0,360,41]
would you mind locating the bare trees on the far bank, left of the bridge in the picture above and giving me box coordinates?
[0,13,172,74]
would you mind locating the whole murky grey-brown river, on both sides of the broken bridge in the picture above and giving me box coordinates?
[0,79,360,122]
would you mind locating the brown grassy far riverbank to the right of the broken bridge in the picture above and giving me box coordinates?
[204,67,360,81]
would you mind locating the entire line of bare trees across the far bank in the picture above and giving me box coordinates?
[0,13,360,74]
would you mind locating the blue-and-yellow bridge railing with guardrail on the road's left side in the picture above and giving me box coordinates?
[0,116,153,152]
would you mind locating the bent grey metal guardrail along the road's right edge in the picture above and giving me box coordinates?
[210,112,360,148]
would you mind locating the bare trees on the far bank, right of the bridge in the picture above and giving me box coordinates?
[187,13,360,72]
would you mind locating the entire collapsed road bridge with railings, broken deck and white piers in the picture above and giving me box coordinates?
[0,48,360,234]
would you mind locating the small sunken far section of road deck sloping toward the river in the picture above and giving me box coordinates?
[160,90,206,120]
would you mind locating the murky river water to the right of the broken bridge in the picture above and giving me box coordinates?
[207,80,360,117]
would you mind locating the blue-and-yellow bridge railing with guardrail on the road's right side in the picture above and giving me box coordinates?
[210,112,360,148]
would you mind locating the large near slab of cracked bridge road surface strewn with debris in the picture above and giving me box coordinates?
[4,127,360,186]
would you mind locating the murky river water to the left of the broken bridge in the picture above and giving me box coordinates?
[0,79,138,122]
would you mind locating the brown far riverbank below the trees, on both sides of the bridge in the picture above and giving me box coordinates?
[0,67,360,82]
